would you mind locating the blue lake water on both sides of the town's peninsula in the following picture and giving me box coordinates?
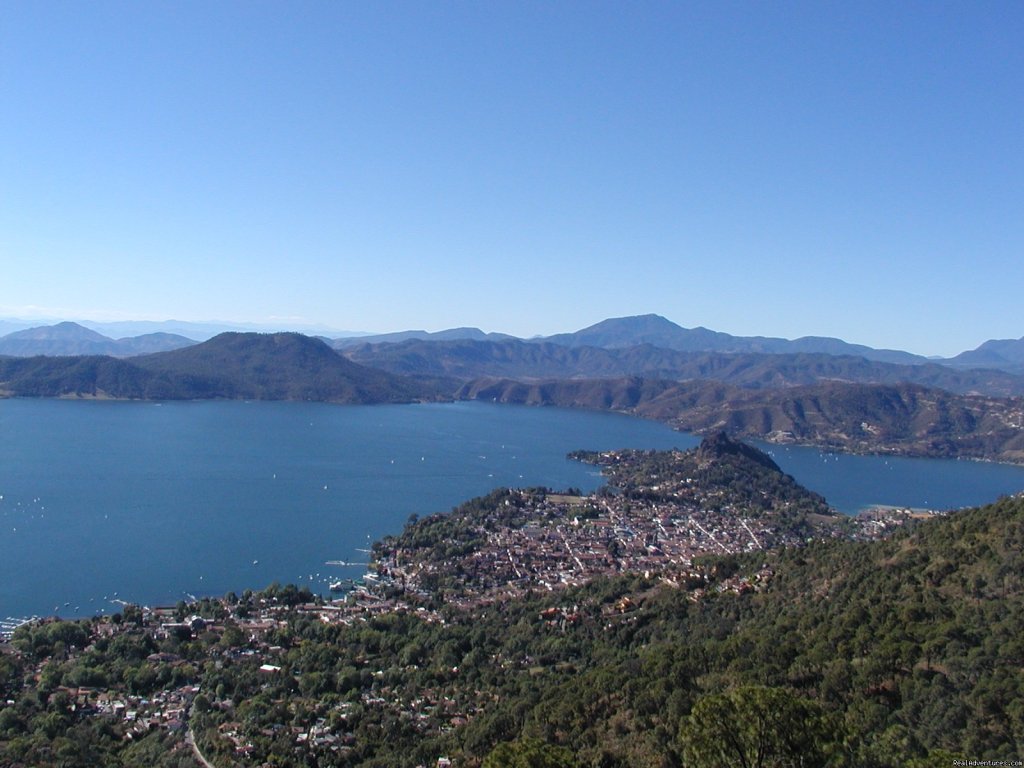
[0,399,1024,618]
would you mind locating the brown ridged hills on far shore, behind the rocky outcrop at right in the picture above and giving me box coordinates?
[457,378,1024,463]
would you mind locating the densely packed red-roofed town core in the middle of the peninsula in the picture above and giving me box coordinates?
[378,479,823,607]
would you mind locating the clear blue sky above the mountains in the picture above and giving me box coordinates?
[0,0,1024,354]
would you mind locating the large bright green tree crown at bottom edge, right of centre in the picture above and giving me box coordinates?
[680,686,838,768]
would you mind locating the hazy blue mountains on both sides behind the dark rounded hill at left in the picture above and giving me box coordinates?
[0,314,1024,396]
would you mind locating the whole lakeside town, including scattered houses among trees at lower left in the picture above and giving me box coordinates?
[0,436,950,765]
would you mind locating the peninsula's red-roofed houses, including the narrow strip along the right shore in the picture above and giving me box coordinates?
[368,444,929,608]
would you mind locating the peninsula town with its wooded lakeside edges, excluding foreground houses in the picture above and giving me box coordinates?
[371,442,933,608]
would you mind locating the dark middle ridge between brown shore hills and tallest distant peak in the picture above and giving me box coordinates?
[344,340,1024,396]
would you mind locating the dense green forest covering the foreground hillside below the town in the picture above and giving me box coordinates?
[0,497,1024,768]
